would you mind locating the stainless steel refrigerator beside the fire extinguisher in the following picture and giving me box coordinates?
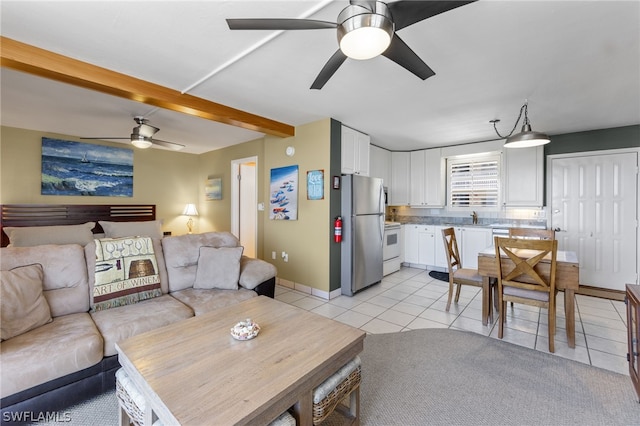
[340,175,384,296]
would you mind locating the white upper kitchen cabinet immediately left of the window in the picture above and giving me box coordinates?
[410,148,446,208]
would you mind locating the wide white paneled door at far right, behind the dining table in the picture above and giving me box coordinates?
[549,151,638,290]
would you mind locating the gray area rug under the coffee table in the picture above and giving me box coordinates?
[31,329,640,426]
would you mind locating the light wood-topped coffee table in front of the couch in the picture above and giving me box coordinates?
[116,296,365,426]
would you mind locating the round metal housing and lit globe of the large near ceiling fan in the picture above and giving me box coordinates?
[338,2,393,60]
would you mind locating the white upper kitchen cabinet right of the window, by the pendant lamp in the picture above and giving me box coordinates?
[503,146,544,208]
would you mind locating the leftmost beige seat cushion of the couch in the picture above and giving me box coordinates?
[0,313,103,398]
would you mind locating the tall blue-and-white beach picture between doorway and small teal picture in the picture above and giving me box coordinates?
[269,165,298,220]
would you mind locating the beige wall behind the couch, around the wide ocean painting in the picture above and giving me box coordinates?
[0,127,200,235]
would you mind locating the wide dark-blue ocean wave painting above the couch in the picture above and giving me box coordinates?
[40,138,133,197]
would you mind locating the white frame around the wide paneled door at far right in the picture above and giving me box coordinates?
[545,148,640,284]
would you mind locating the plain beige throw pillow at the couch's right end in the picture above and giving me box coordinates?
[193,247,244,290]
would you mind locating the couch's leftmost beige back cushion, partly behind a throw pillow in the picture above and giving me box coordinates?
[0,244,90,318]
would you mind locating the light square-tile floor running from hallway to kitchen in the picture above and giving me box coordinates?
[276,268,629,375]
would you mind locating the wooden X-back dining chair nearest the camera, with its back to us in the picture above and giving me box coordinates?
[494,237,558,353]
